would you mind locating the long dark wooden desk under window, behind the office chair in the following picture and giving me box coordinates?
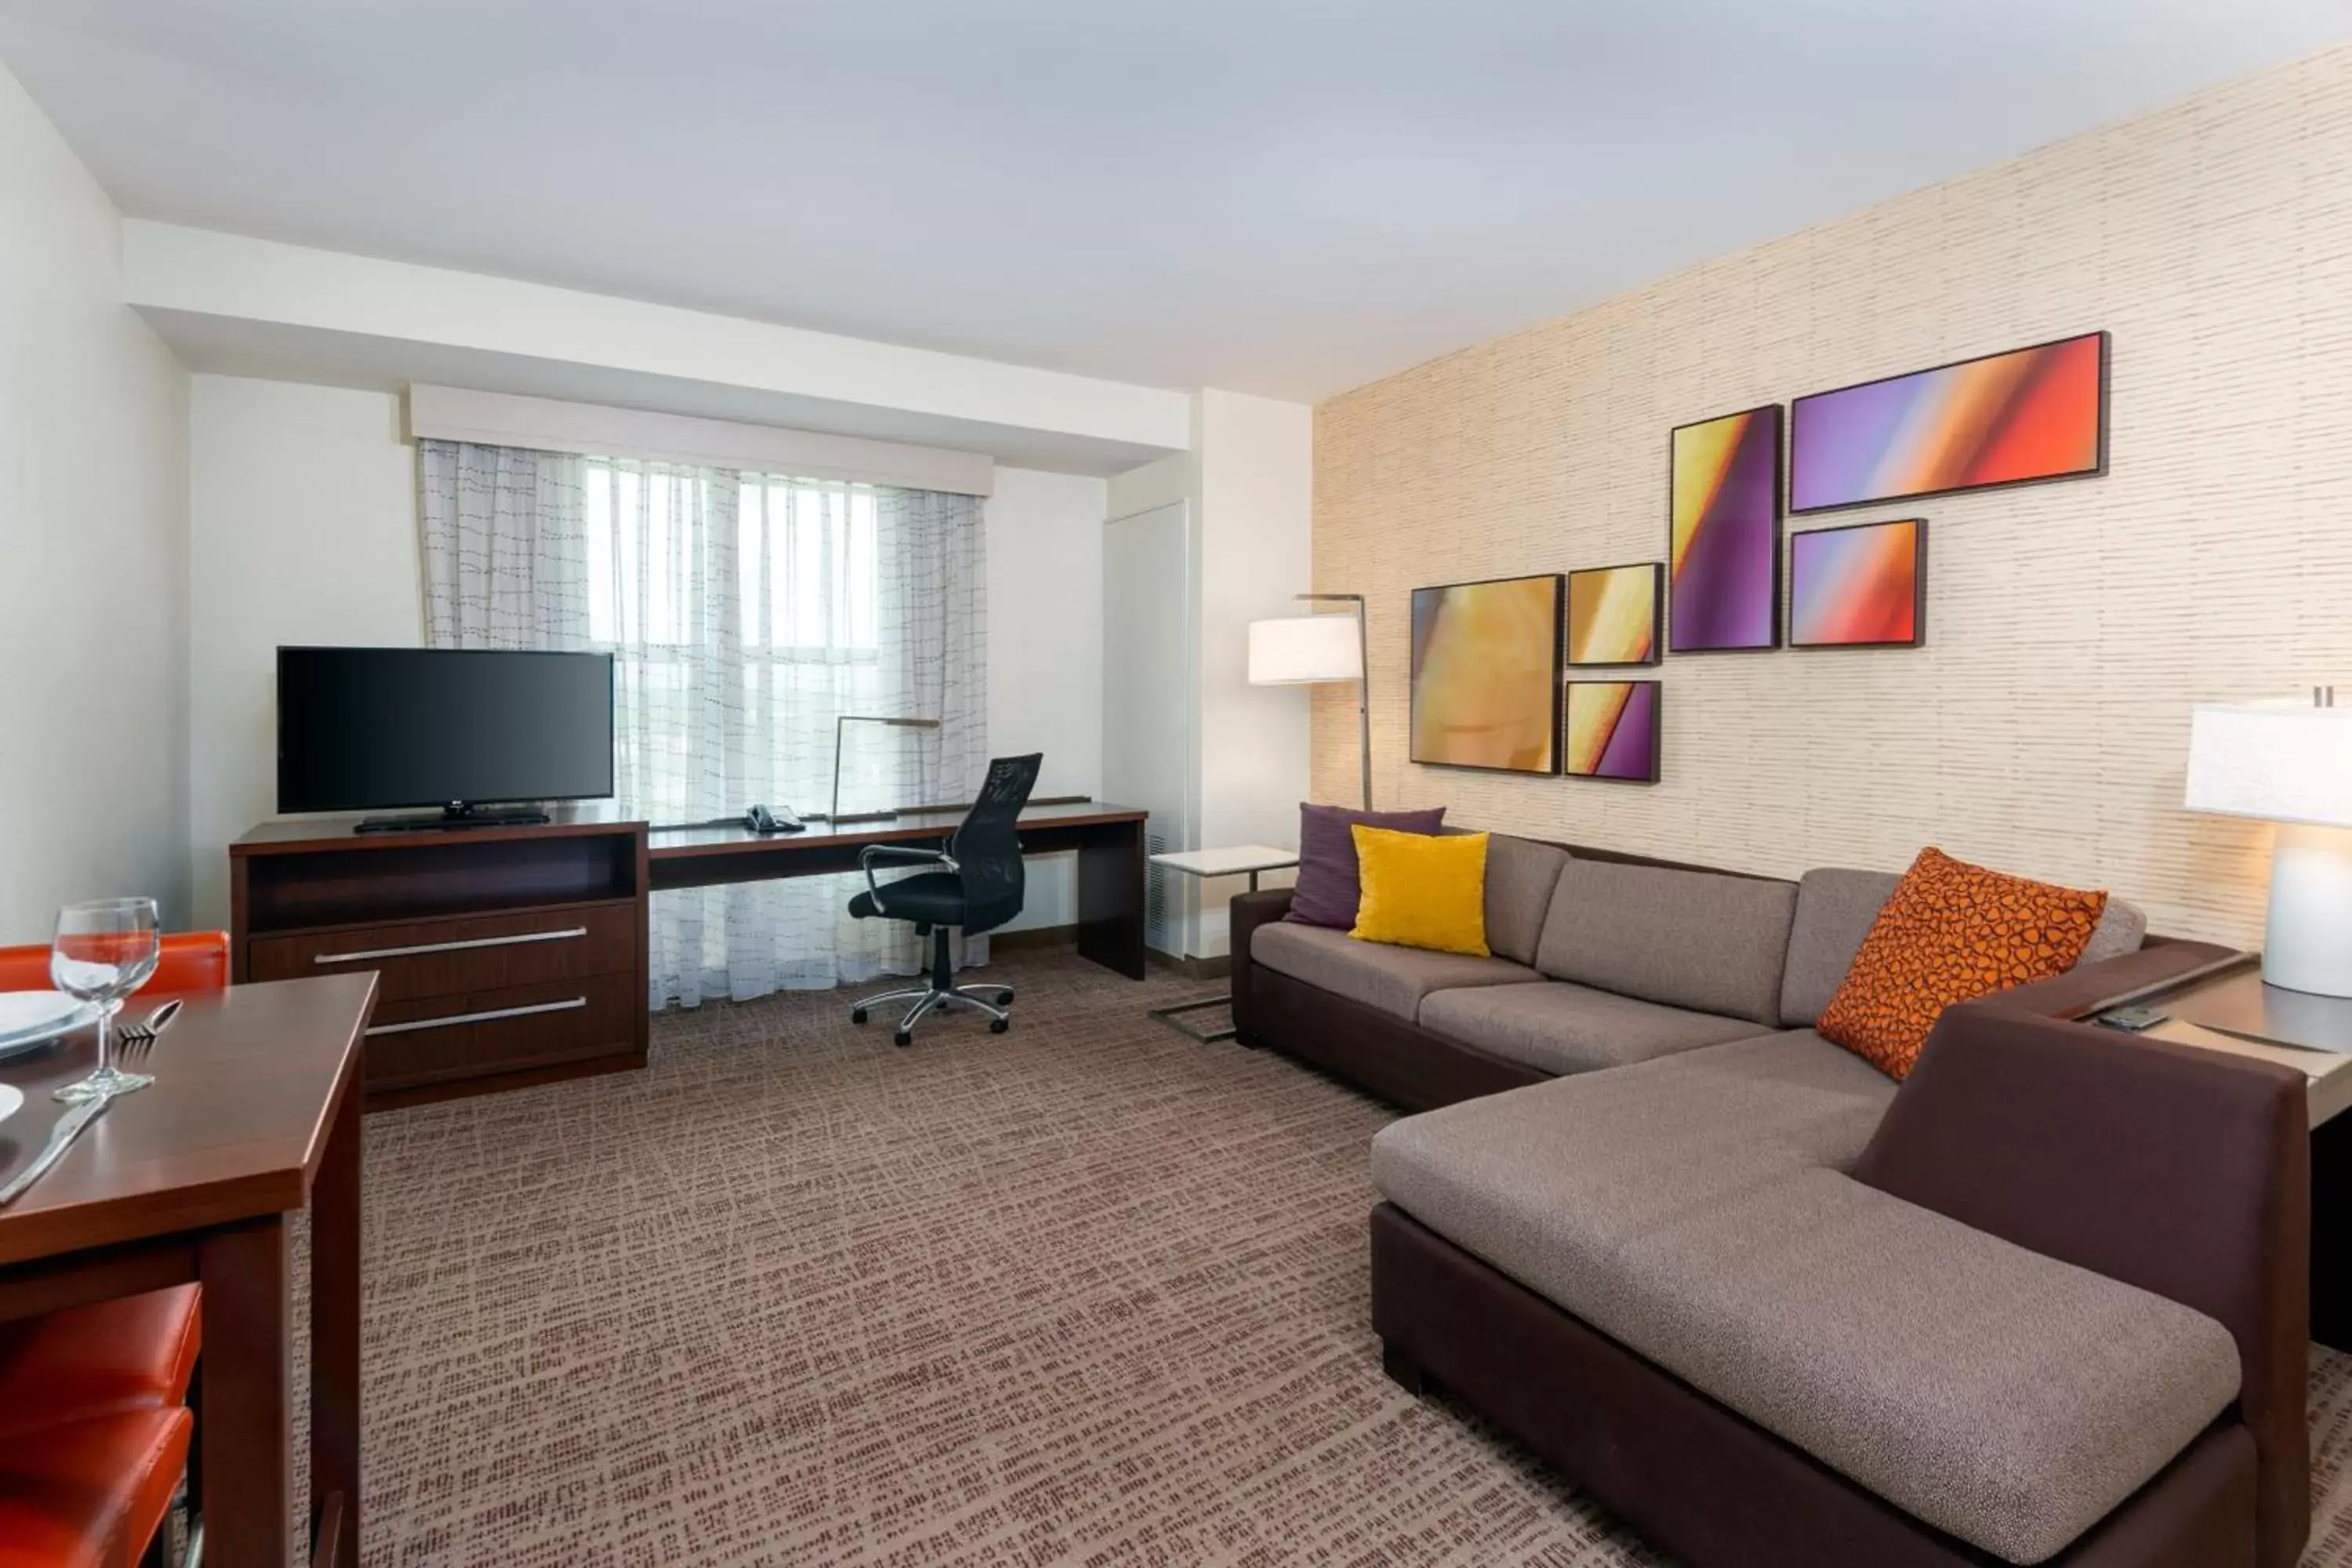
[649,801,1150,980]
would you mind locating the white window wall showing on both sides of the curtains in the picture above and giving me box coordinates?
[188,376,1103,926]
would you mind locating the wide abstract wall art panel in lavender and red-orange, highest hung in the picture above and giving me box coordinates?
[1788,332,2107,513]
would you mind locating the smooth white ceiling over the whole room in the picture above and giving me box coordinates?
[0,0,2352,397]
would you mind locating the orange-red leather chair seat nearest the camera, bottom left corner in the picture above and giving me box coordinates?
[0,1406,193,1568]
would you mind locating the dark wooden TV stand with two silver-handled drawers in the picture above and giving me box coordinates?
[228,813,652,1109]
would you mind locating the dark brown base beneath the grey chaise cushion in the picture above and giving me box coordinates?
[1374,1203,2256,1568]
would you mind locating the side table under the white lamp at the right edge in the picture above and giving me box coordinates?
[2086,952,2352,1352]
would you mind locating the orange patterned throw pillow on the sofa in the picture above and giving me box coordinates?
[1818,848,2107,1079]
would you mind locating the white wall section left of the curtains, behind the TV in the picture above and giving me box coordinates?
[188,376,423,924]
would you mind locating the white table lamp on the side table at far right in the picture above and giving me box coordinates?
[2185,687,2352,996]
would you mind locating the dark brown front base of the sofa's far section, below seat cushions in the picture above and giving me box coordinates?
[1235,964,1552,1109]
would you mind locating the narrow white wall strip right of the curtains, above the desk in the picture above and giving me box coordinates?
[988,468,1108,931]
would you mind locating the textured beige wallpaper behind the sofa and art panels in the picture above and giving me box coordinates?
[1315,47,2352,942]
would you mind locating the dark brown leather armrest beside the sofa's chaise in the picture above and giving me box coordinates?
[1853,1001,2310,1568]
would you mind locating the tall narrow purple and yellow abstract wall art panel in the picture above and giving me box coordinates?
[1665,405,1780,654]
